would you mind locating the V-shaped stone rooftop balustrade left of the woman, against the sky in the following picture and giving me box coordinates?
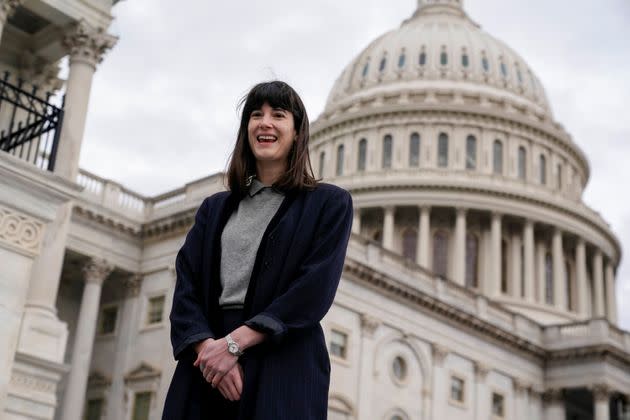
[77,170,224,222]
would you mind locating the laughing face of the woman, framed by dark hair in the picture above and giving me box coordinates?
[247,102,297,166]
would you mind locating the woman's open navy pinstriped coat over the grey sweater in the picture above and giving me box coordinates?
[163,183,352,420]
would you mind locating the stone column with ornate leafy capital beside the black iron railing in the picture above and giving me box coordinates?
[55,21,117,181]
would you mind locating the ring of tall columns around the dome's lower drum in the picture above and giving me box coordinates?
[353,200,617,324]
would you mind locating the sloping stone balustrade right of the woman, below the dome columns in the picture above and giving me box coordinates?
[348,234,543,346]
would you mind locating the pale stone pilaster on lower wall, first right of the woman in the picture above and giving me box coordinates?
[357,314,380,419]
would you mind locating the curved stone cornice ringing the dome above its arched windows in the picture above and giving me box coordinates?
[311,103,590,182]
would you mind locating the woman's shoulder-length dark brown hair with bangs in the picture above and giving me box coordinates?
[226,80,317,197]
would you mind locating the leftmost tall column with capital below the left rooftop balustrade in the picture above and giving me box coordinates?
[61,259,113,419]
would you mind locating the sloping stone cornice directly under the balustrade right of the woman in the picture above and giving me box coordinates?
[344,258,546,359]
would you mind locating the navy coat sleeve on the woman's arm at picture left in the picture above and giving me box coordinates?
[170,198,215,360]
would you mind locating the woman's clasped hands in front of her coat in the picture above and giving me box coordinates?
[194,338,243,401]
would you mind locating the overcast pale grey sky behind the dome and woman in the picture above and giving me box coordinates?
[81,0,630,329]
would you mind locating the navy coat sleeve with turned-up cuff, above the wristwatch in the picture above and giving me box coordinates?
[245,190,352,342]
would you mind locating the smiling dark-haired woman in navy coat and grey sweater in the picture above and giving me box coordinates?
[163,81,353,420]
